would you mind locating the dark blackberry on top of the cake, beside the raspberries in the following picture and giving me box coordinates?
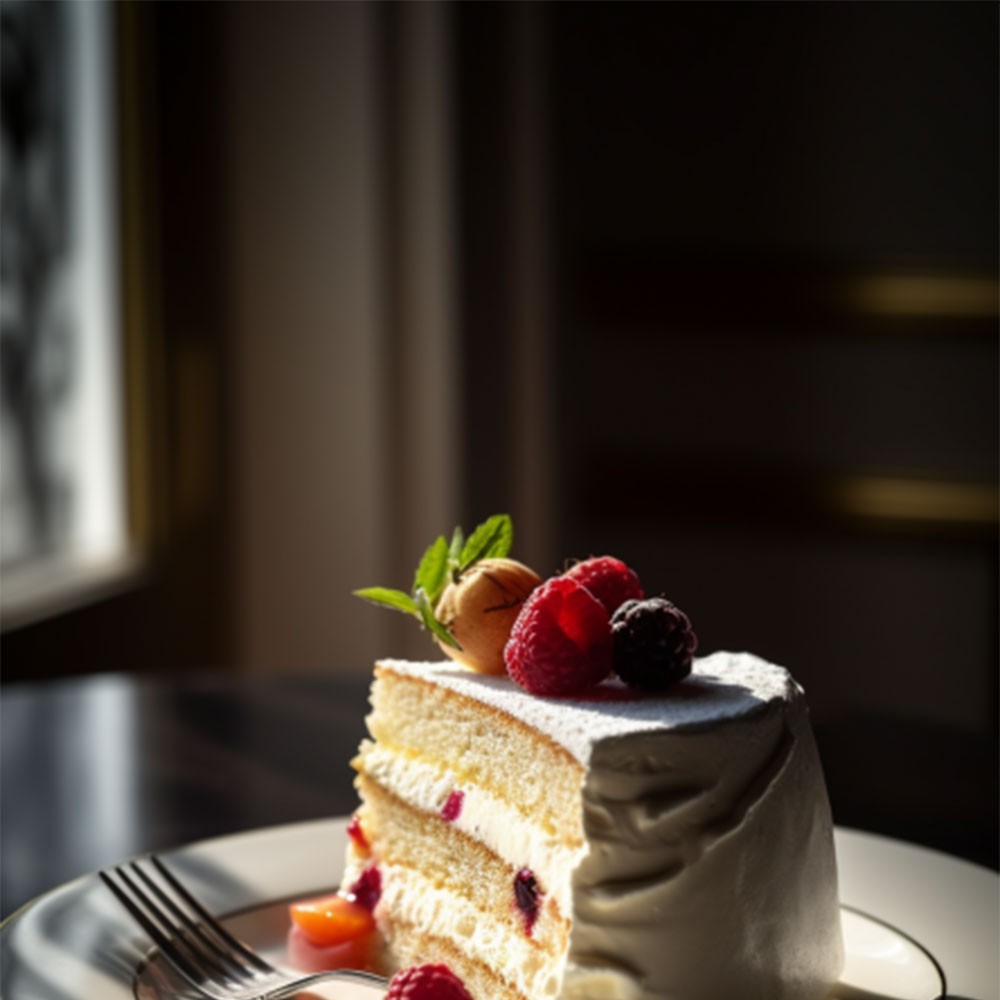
[611,597,698,691]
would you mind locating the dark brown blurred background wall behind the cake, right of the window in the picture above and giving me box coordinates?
[2,2,998,864]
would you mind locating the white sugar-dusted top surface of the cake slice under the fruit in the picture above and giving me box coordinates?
[379,652,801,764]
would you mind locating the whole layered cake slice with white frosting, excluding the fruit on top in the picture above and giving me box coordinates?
[344,653,842,1000]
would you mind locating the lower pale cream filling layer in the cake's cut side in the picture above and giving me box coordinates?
[375,865,566,1000]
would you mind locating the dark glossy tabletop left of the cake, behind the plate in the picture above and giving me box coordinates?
[0,674,369,916]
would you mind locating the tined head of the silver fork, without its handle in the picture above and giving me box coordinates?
[100,855,276,991]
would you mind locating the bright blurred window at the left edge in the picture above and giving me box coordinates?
[0,2,129,625]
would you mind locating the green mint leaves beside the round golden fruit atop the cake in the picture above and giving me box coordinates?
[353,514,514,649]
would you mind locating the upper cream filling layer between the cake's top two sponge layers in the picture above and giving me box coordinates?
[358,740,586,916]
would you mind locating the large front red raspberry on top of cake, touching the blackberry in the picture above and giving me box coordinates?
[504,575,613,696]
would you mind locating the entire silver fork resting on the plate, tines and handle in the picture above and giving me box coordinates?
[100,855,388,1000]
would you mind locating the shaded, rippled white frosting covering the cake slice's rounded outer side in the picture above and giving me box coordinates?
[566,699,842,1000]
